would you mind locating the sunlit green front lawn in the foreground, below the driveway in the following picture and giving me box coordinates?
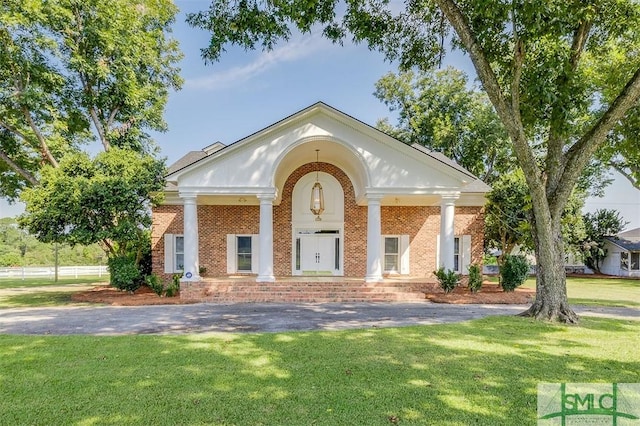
[0,317,640,425]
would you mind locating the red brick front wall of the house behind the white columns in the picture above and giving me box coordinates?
[151,163,484,277]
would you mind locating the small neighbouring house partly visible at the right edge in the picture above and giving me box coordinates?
[600,228,640,277]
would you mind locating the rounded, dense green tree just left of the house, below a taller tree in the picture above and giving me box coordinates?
[19,147,164,263]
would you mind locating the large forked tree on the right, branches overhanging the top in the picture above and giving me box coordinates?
[188,0,640,322]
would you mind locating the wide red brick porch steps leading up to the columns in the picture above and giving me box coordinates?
[180,281,437,303]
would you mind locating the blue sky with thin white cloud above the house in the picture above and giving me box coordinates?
[0,0,640,228]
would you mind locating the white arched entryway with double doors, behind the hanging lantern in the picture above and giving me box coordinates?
[291,172,344,276]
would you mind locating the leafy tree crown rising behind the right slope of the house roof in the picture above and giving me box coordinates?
[374,68,513,184]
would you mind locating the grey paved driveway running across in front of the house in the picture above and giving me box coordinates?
[0,302,640,335]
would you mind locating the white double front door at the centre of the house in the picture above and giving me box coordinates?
[299,234,340,275]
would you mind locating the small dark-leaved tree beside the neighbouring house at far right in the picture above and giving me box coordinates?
[579,209,628,272]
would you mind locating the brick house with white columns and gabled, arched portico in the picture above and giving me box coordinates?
[152,103,490,302]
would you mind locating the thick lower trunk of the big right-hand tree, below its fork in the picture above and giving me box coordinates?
[520,206,579,324]
